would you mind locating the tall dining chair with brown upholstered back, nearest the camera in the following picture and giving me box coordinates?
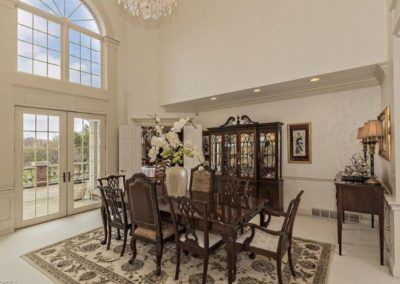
[126,173,175,276]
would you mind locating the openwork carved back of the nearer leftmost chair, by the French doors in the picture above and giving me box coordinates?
[99,186,128,228]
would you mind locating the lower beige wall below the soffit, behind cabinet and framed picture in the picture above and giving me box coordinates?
[197,87,380,214]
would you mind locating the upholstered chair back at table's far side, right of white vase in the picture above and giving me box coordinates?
[189,165,215,198]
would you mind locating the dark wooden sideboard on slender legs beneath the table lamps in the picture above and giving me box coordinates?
[335,173,385,265]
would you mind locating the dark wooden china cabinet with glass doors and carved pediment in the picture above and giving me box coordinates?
[208,115,283,210]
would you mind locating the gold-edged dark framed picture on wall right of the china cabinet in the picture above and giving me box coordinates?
[287,122,311,164]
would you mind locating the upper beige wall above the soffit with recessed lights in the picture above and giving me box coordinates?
[160,0,386,104]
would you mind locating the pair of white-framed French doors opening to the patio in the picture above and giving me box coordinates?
[15,108,105,227]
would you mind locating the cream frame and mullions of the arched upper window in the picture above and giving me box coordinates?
[14,1,107,90]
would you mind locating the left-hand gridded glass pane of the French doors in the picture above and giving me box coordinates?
[16,109,65,225]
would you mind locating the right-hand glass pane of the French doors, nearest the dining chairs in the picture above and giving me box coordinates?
[68,115,104,211]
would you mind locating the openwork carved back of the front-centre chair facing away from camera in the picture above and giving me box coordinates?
[169,196,209,248]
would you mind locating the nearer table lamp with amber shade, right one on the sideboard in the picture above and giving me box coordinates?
[363,120,383,185]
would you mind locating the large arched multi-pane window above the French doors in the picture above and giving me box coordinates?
[17,0,102,88]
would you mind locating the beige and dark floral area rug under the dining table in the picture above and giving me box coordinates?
[23,229,334,284]
